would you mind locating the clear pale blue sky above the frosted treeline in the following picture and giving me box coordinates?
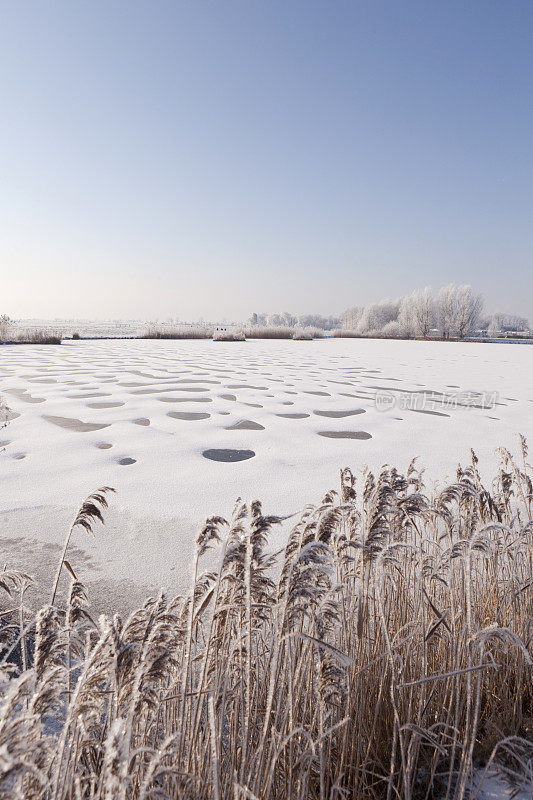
[0,0,533,320]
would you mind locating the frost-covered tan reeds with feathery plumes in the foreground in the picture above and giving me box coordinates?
[0,441,533,800]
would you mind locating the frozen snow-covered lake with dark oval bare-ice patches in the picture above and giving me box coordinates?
[0,339,533,611]
